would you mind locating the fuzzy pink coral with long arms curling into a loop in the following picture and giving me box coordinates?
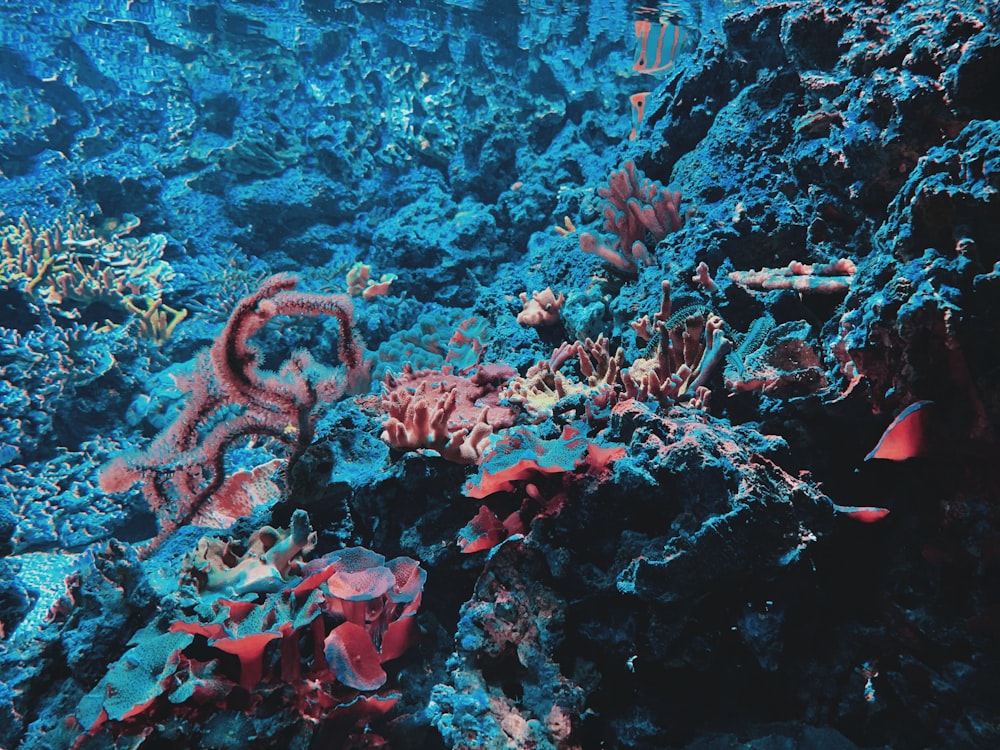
[100,274,365,545]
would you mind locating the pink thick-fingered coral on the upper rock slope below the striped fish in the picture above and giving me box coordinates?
[580,161,682,276]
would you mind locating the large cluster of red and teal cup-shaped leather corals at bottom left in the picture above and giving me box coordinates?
[75,511,426,743]
